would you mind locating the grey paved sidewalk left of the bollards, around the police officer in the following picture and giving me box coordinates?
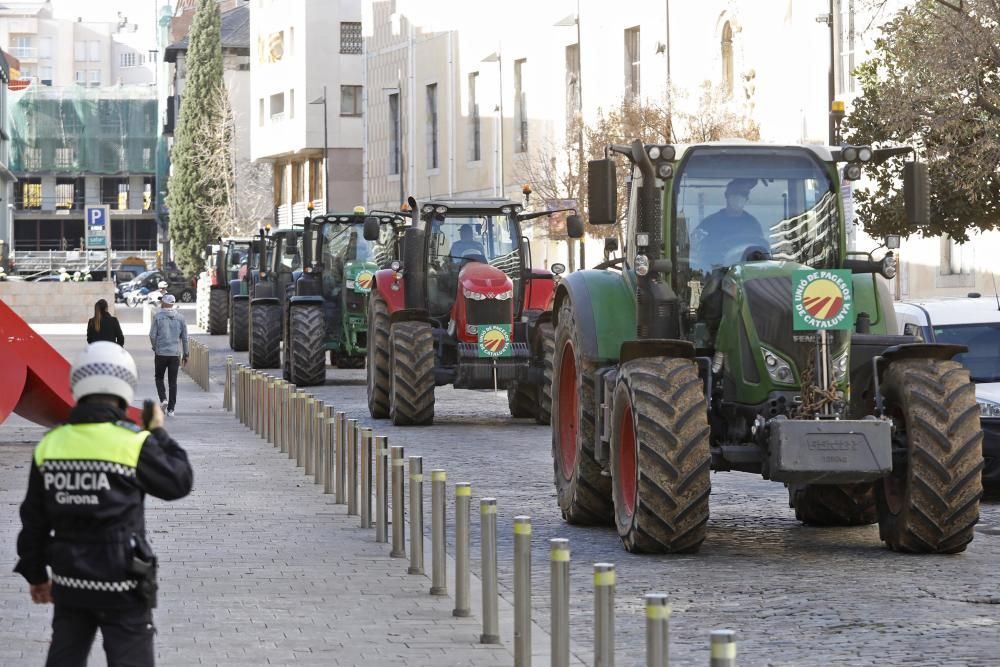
[0,336,516,667]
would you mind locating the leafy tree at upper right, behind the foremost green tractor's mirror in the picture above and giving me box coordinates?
[844,0,1000,241]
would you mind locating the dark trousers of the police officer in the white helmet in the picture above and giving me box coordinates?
[45,604,156,667]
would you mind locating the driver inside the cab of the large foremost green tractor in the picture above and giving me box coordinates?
[691,178,770,272]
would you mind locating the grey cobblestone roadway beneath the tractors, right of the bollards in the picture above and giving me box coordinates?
[202,336,1000,665]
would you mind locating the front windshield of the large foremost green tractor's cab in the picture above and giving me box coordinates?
[674,147,840,285]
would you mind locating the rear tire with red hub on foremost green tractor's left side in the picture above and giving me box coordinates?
[552,299,614,525]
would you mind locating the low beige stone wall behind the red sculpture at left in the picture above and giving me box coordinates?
[0,280,115,324]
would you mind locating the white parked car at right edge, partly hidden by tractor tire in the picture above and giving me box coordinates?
[895,293,1000,488]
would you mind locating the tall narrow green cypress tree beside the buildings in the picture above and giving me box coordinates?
[167,0,228,275]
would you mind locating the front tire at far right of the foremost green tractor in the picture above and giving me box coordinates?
[876,359,983,553]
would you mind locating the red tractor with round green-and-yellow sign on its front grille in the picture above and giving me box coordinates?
[365,197,583,426]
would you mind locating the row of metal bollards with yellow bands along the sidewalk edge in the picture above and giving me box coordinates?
[230,368,736,667]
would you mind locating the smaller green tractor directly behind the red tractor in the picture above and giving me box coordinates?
[282,207,405,386]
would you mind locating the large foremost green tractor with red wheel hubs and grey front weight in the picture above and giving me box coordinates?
[552,141,983,553]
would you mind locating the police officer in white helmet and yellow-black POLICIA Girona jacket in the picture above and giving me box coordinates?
[14,341,193,666]
